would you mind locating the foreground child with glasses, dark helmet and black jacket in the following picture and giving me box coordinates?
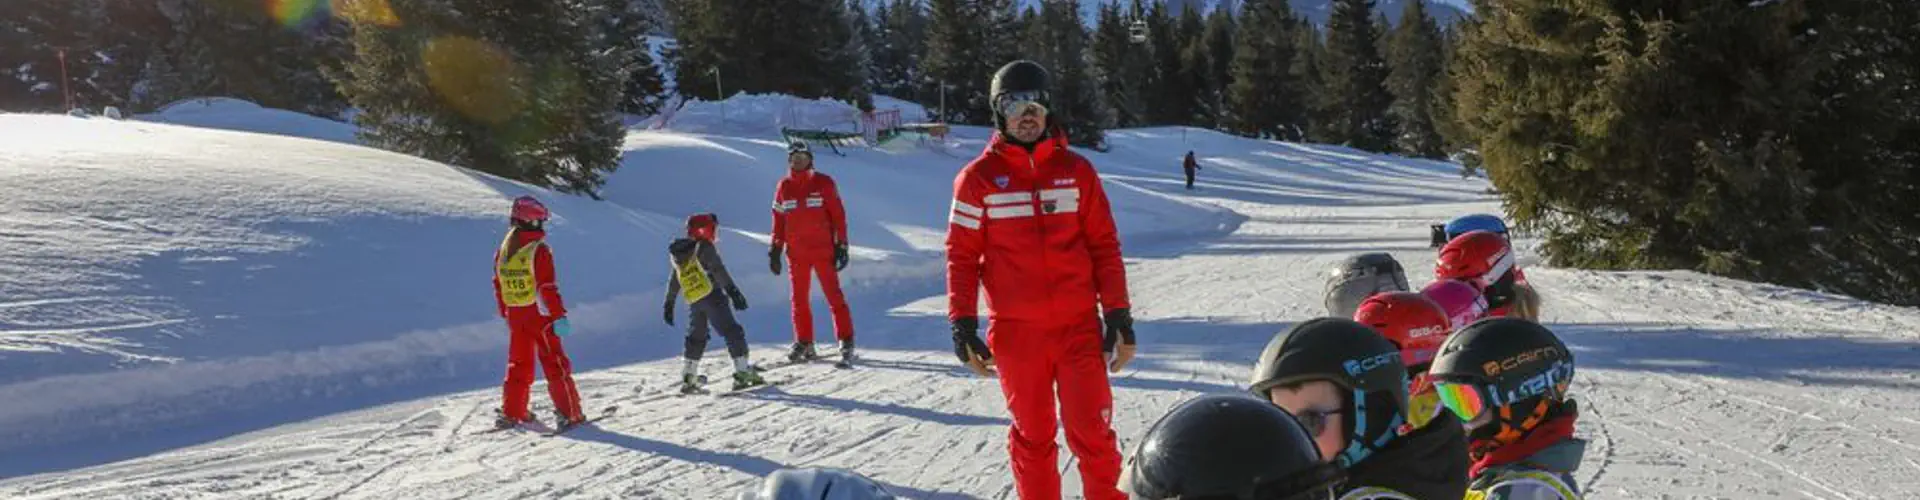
[1248,317,1467,500]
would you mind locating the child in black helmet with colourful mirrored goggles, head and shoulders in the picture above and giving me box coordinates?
[1428,317,1586,500]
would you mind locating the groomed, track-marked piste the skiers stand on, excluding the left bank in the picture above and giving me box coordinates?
[0,112,1920,500]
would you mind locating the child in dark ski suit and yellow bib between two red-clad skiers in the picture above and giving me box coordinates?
[666,213,766,394]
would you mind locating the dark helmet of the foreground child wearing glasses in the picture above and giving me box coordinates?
[1248,317,1407,467]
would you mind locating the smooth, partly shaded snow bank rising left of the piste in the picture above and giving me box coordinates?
[0,115,678,457]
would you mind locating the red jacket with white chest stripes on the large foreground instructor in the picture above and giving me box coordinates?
[947,133,1127,323]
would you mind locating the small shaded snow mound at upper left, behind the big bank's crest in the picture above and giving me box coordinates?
[136,98,359,144]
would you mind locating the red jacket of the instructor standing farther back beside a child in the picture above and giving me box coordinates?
[774,169,847,256]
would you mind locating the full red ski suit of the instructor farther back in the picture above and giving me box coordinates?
[774,167,852,342]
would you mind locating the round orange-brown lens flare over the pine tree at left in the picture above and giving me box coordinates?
[420,37,526,125]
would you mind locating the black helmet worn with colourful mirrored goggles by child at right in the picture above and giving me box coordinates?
[1427,317,1574,442]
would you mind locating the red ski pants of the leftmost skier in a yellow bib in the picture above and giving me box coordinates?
[501,306,580,419]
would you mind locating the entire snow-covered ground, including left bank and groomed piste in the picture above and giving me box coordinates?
[0,96,1920,498]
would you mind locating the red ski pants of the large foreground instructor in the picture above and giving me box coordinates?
[987,313,1127,500]
